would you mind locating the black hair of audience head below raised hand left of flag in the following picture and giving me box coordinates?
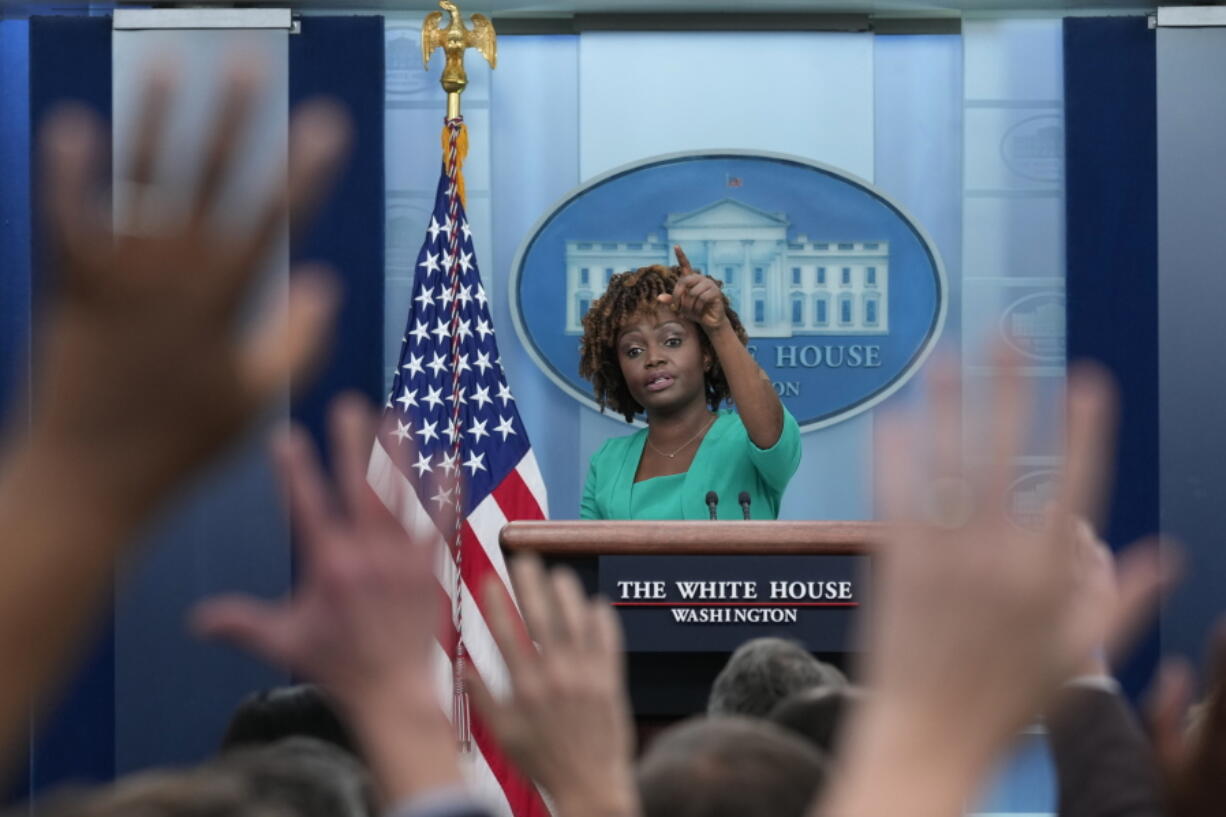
[221,683,360,756]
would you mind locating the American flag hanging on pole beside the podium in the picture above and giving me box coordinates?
[368,120,549,817]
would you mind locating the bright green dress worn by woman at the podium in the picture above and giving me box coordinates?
[580,409,801,519]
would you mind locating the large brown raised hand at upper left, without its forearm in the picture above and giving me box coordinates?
[33,65,348,508]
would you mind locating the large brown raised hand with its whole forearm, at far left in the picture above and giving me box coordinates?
[0,60,348,767]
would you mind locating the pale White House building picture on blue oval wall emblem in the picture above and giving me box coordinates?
[566,199,890,337]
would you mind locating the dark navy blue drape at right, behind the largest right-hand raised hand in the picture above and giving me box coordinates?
[1064,17,1159,693]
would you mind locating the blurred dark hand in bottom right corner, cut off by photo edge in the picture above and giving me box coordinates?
[1149,618,1226,817]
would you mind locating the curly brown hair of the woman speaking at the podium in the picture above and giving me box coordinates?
[579,264,749,423]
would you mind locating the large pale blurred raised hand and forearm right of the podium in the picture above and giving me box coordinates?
[815,358,1165,817]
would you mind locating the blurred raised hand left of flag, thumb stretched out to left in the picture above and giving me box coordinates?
[195,397,462,805]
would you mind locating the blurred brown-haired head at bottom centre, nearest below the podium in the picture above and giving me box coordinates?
[639,718,826,817]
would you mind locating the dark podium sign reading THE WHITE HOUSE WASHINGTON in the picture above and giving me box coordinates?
[598,554,869,653]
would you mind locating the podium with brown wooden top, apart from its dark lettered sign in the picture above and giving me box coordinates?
[499,520,883,725]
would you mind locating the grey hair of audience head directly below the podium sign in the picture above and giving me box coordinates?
[706,638,847,718]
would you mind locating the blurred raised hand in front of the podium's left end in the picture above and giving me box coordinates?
[468,556,639,817]
